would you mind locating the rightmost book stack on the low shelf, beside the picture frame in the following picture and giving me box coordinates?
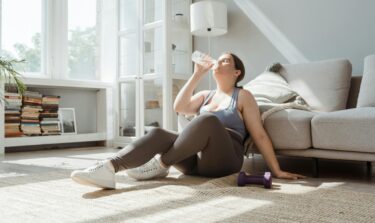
[40,95,61,135]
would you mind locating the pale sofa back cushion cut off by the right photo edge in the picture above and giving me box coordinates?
[357,55,375,107]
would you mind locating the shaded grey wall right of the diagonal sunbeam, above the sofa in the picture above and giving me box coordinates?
[251,0,375,74]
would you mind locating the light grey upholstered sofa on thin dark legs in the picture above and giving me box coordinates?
[250,55,375,176]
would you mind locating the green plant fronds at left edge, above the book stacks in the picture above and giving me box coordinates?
[0,57,26,103]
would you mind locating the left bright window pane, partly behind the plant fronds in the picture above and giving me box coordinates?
[1,0,44,73]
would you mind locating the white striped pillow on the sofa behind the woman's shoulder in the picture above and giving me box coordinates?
[244,71,296,105]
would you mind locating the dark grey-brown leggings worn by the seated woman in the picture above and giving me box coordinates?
[111,113,244,177]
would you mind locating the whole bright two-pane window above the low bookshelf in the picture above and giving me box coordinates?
[0,0,100,80]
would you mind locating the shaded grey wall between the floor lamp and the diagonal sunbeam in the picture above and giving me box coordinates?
[193,0,287,88]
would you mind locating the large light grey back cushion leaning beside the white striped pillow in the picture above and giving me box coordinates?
[280,59,352,111]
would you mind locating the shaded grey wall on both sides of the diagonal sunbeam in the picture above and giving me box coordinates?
[194,0,375,89]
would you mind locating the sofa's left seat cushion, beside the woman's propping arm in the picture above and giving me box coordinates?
[264,109,316,149]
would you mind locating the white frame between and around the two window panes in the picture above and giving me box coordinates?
[0,0,102,81]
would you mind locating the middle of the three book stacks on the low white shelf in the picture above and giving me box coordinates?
[21,91,43,135]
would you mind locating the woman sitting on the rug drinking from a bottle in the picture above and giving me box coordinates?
[71,53,304,188]
